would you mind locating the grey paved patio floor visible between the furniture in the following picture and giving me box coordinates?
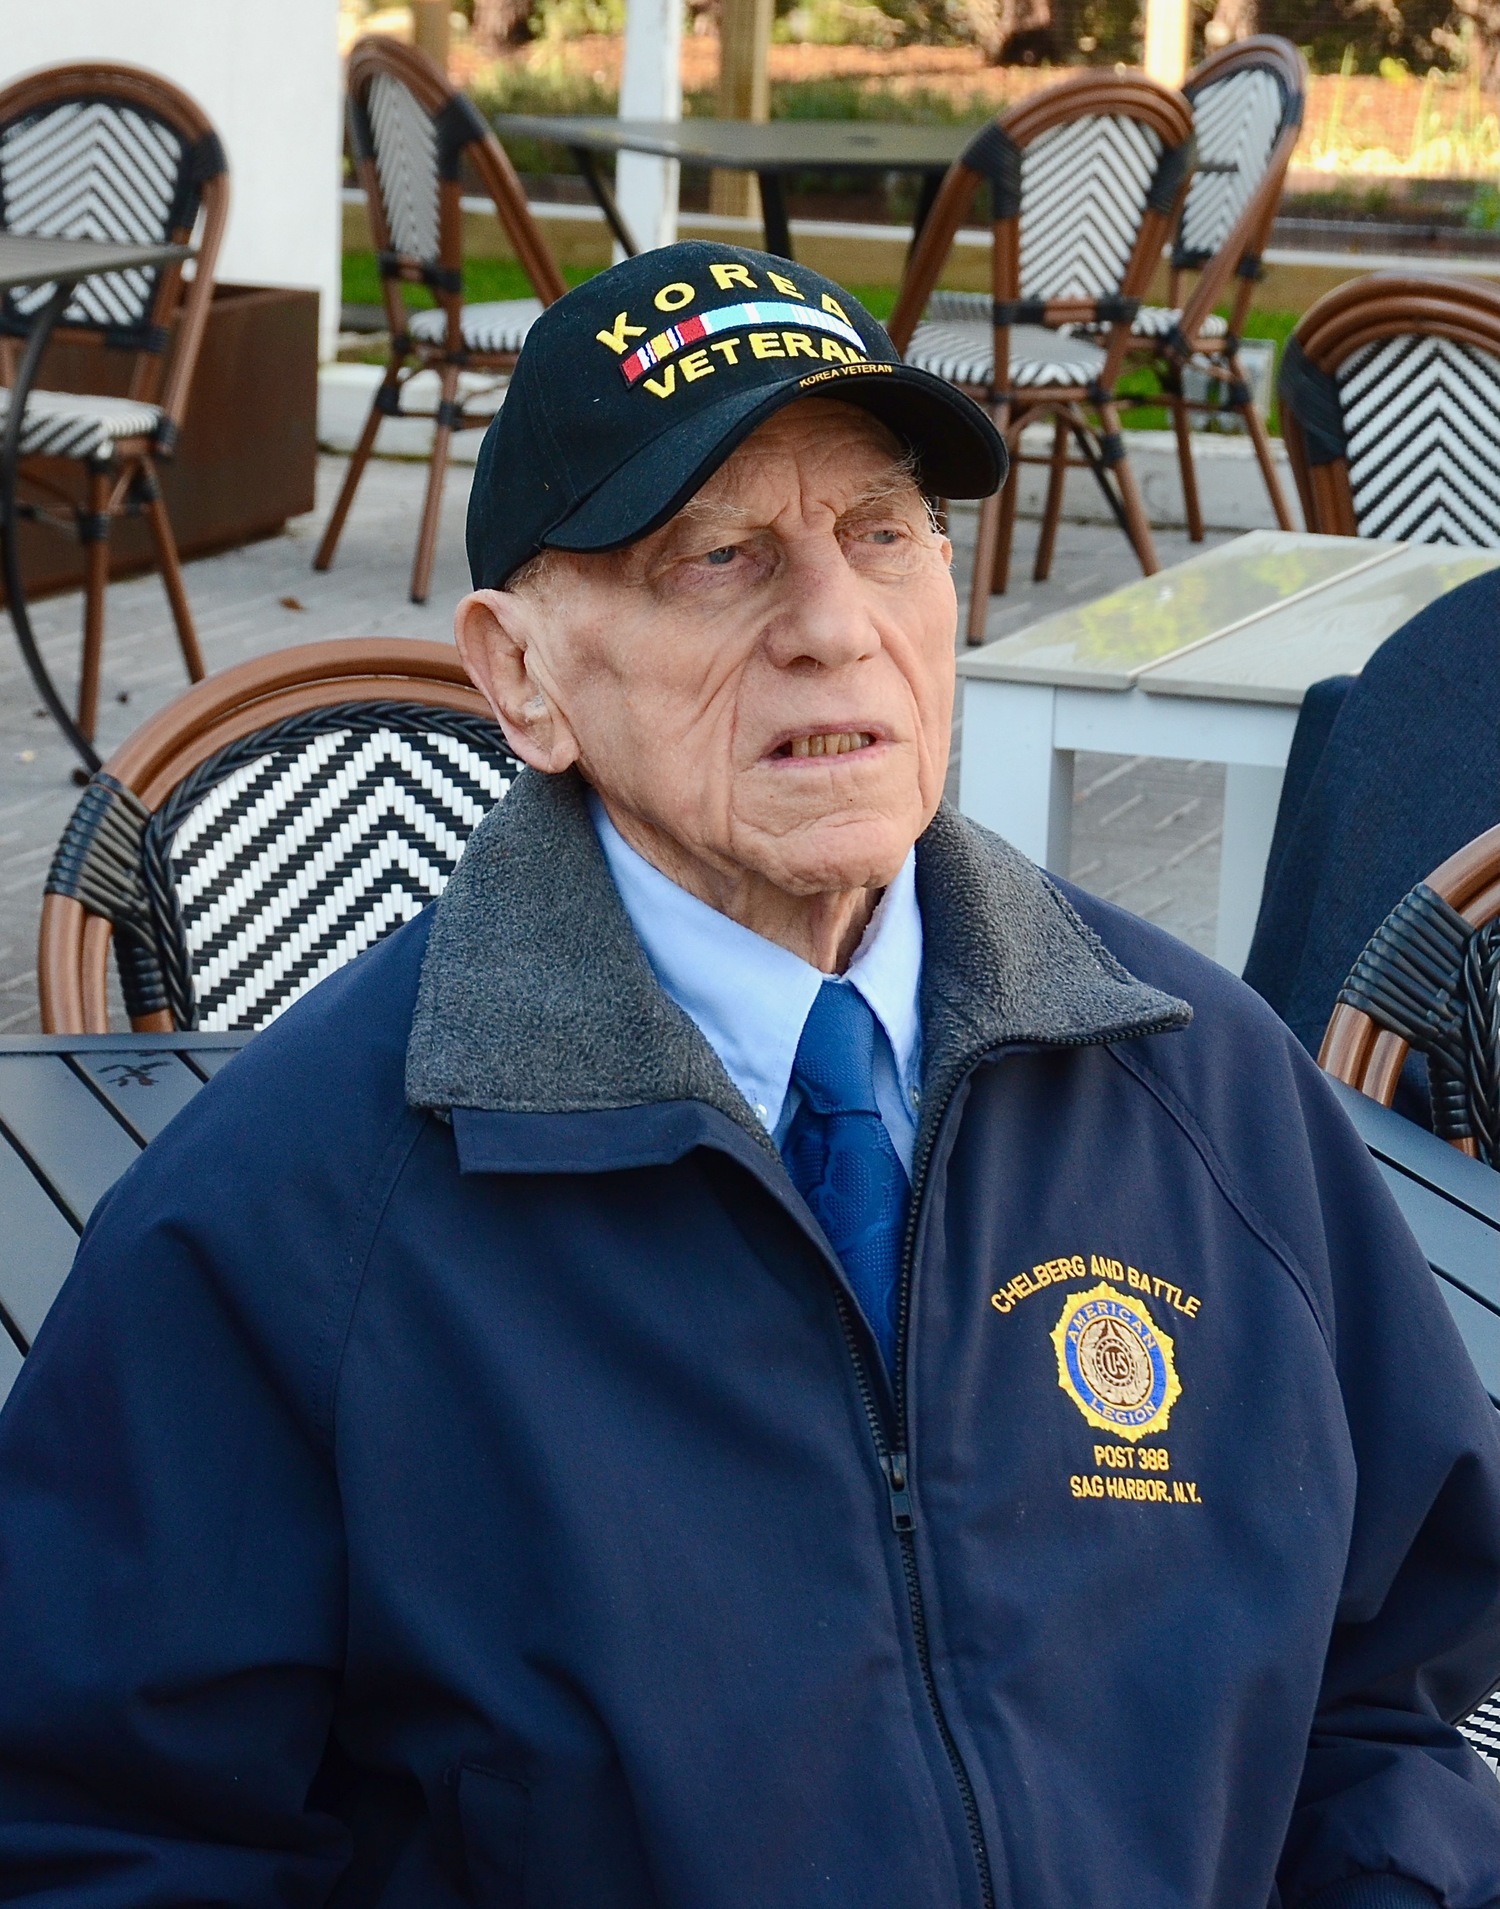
[0,456,1229,1033]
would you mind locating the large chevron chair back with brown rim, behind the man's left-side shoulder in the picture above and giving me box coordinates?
[38,638,521,1035]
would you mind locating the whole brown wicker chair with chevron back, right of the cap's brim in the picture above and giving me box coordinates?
[889,73,1195,643]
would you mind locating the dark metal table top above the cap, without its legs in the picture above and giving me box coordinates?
[492,113,973,172]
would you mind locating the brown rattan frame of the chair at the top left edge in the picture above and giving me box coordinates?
[0,61,229,741]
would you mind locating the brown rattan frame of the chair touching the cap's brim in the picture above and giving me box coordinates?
[887,73,1193,643]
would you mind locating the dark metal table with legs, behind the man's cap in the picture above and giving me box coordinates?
[492,113,973,258]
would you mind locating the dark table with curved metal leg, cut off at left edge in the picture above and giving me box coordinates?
[0,231,191,769]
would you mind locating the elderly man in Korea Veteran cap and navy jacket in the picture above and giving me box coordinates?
[0,244,1500,1909]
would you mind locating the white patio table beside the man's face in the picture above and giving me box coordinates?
[958,531,1500,974]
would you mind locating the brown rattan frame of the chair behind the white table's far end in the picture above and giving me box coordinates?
[1281,271,1500,536]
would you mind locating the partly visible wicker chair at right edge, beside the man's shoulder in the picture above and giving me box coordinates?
[1319,827,1500,1166]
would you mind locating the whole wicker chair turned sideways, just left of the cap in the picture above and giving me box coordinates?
[313,34,567,603]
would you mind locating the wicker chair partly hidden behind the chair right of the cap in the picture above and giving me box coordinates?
[1126,34,1307,544]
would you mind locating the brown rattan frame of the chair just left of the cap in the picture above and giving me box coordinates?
[313,34,567,603]
